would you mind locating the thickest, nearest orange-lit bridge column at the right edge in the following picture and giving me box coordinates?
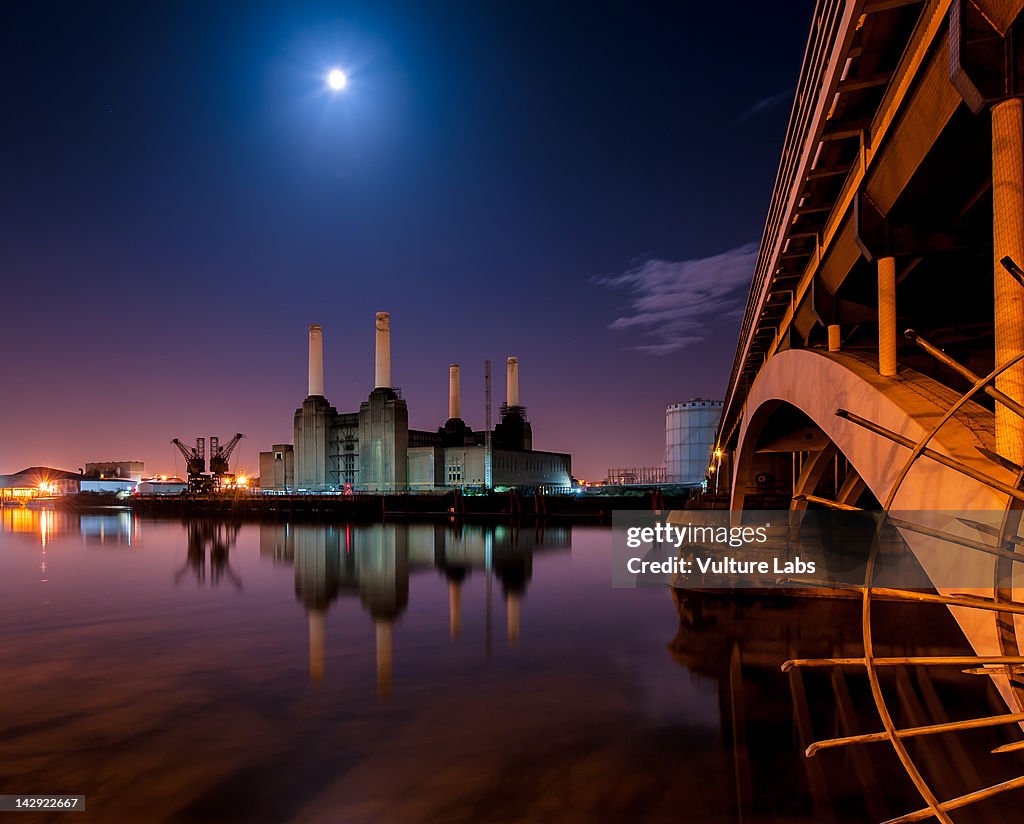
[992,98,1024,463]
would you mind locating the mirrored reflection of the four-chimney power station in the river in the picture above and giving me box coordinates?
[260,523,571,695]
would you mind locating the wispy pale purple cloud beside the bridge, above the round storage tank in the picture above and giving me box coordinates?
[594,244,758,355]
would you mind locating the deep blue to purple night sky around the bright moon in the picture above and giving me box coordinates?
[0,0,813,478]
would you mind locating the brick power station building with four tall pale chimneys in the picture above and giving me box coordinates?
[260,312,572,492]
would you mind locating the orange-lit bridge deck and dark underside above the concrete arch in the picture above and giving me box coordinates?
[712,0,1024,508]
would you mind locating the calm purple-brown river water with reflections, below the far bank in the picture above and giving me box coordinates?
[0,509,1016,822]
